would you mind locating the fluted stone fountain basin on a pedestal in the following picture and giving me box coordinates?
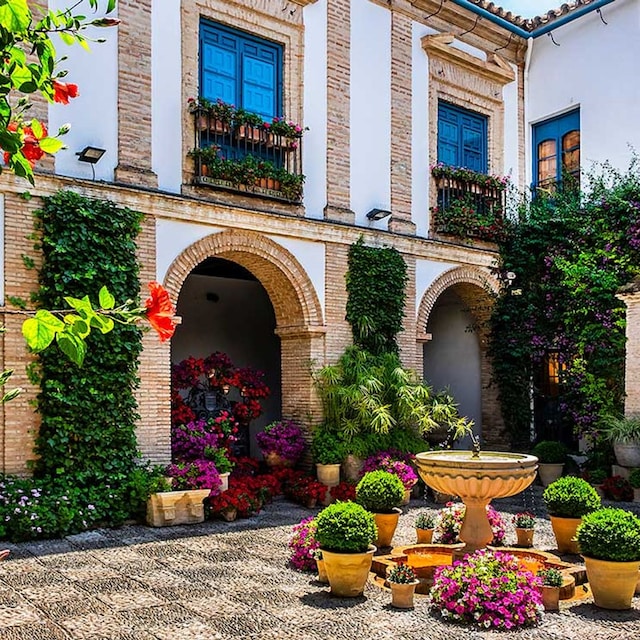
[416,443,538,556]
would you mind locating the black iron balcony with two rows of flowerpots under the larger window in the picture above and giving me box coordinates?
[188,98,304,203]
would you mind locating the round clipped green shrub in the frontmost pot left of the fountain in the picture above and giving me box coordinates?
[316,502,378,553]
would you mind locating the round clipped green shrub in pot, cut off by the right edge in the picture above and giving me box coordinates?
[576,507,640,562]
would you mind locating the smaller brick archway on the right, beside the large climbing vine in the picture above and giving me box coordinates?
[416,267,509,448]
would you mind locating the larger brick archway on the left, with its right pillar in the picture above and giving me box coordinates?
[164,230,325,422]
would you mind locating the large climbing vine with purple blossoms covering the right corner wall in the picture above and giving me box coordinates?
[490,161,640,442]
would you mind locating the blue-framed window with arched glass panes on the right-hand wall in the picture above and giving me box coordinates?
[532,109,580,191]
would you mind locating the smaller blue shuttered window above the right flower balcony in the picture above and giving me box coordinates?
[438,101,488,173]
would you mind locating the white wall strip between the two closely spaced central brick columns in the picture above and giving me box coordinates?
[350,0,391,228]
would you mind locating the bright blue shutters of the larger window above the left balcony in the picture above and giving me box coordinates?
[200,20,282,120]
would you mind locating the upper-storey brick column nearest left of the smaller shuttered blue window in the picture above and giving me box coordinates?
[389,11,416,235]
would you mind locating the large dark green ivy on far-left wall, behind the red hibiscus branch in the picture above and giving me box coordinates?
[34,191,142,522]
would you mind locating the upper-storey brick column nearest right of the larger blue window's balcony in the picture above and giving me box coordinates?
[324,0,355,224]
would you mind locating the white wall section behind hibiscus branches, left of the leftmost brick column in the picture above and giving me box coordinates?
[49,0,118,181]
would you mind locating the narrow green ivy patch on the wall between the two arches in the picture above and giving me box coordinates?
[346,237,407,354]
